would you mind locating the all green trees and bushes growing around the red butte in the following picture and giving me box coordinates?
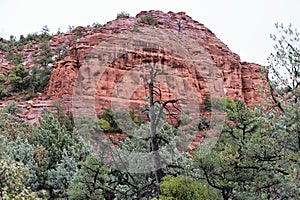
[0,13,300,200]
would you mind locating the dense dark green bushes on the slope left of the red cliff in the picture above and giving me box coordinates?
[0,26,53,99]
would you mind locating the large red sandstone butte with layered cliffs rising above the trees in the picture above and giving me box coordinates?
[0,10,265,148]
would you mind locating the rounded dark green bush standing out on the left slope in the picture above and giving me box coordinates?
[9,65,30,92]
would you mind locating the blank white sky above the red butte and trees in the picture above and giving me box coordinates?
[0,0,300,64]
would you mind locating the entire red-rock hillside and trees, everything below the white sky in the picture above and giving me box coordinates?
[0,11,300,200]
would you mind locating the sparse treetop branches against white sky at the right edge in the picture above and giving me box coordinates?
[267,23,300,104]
